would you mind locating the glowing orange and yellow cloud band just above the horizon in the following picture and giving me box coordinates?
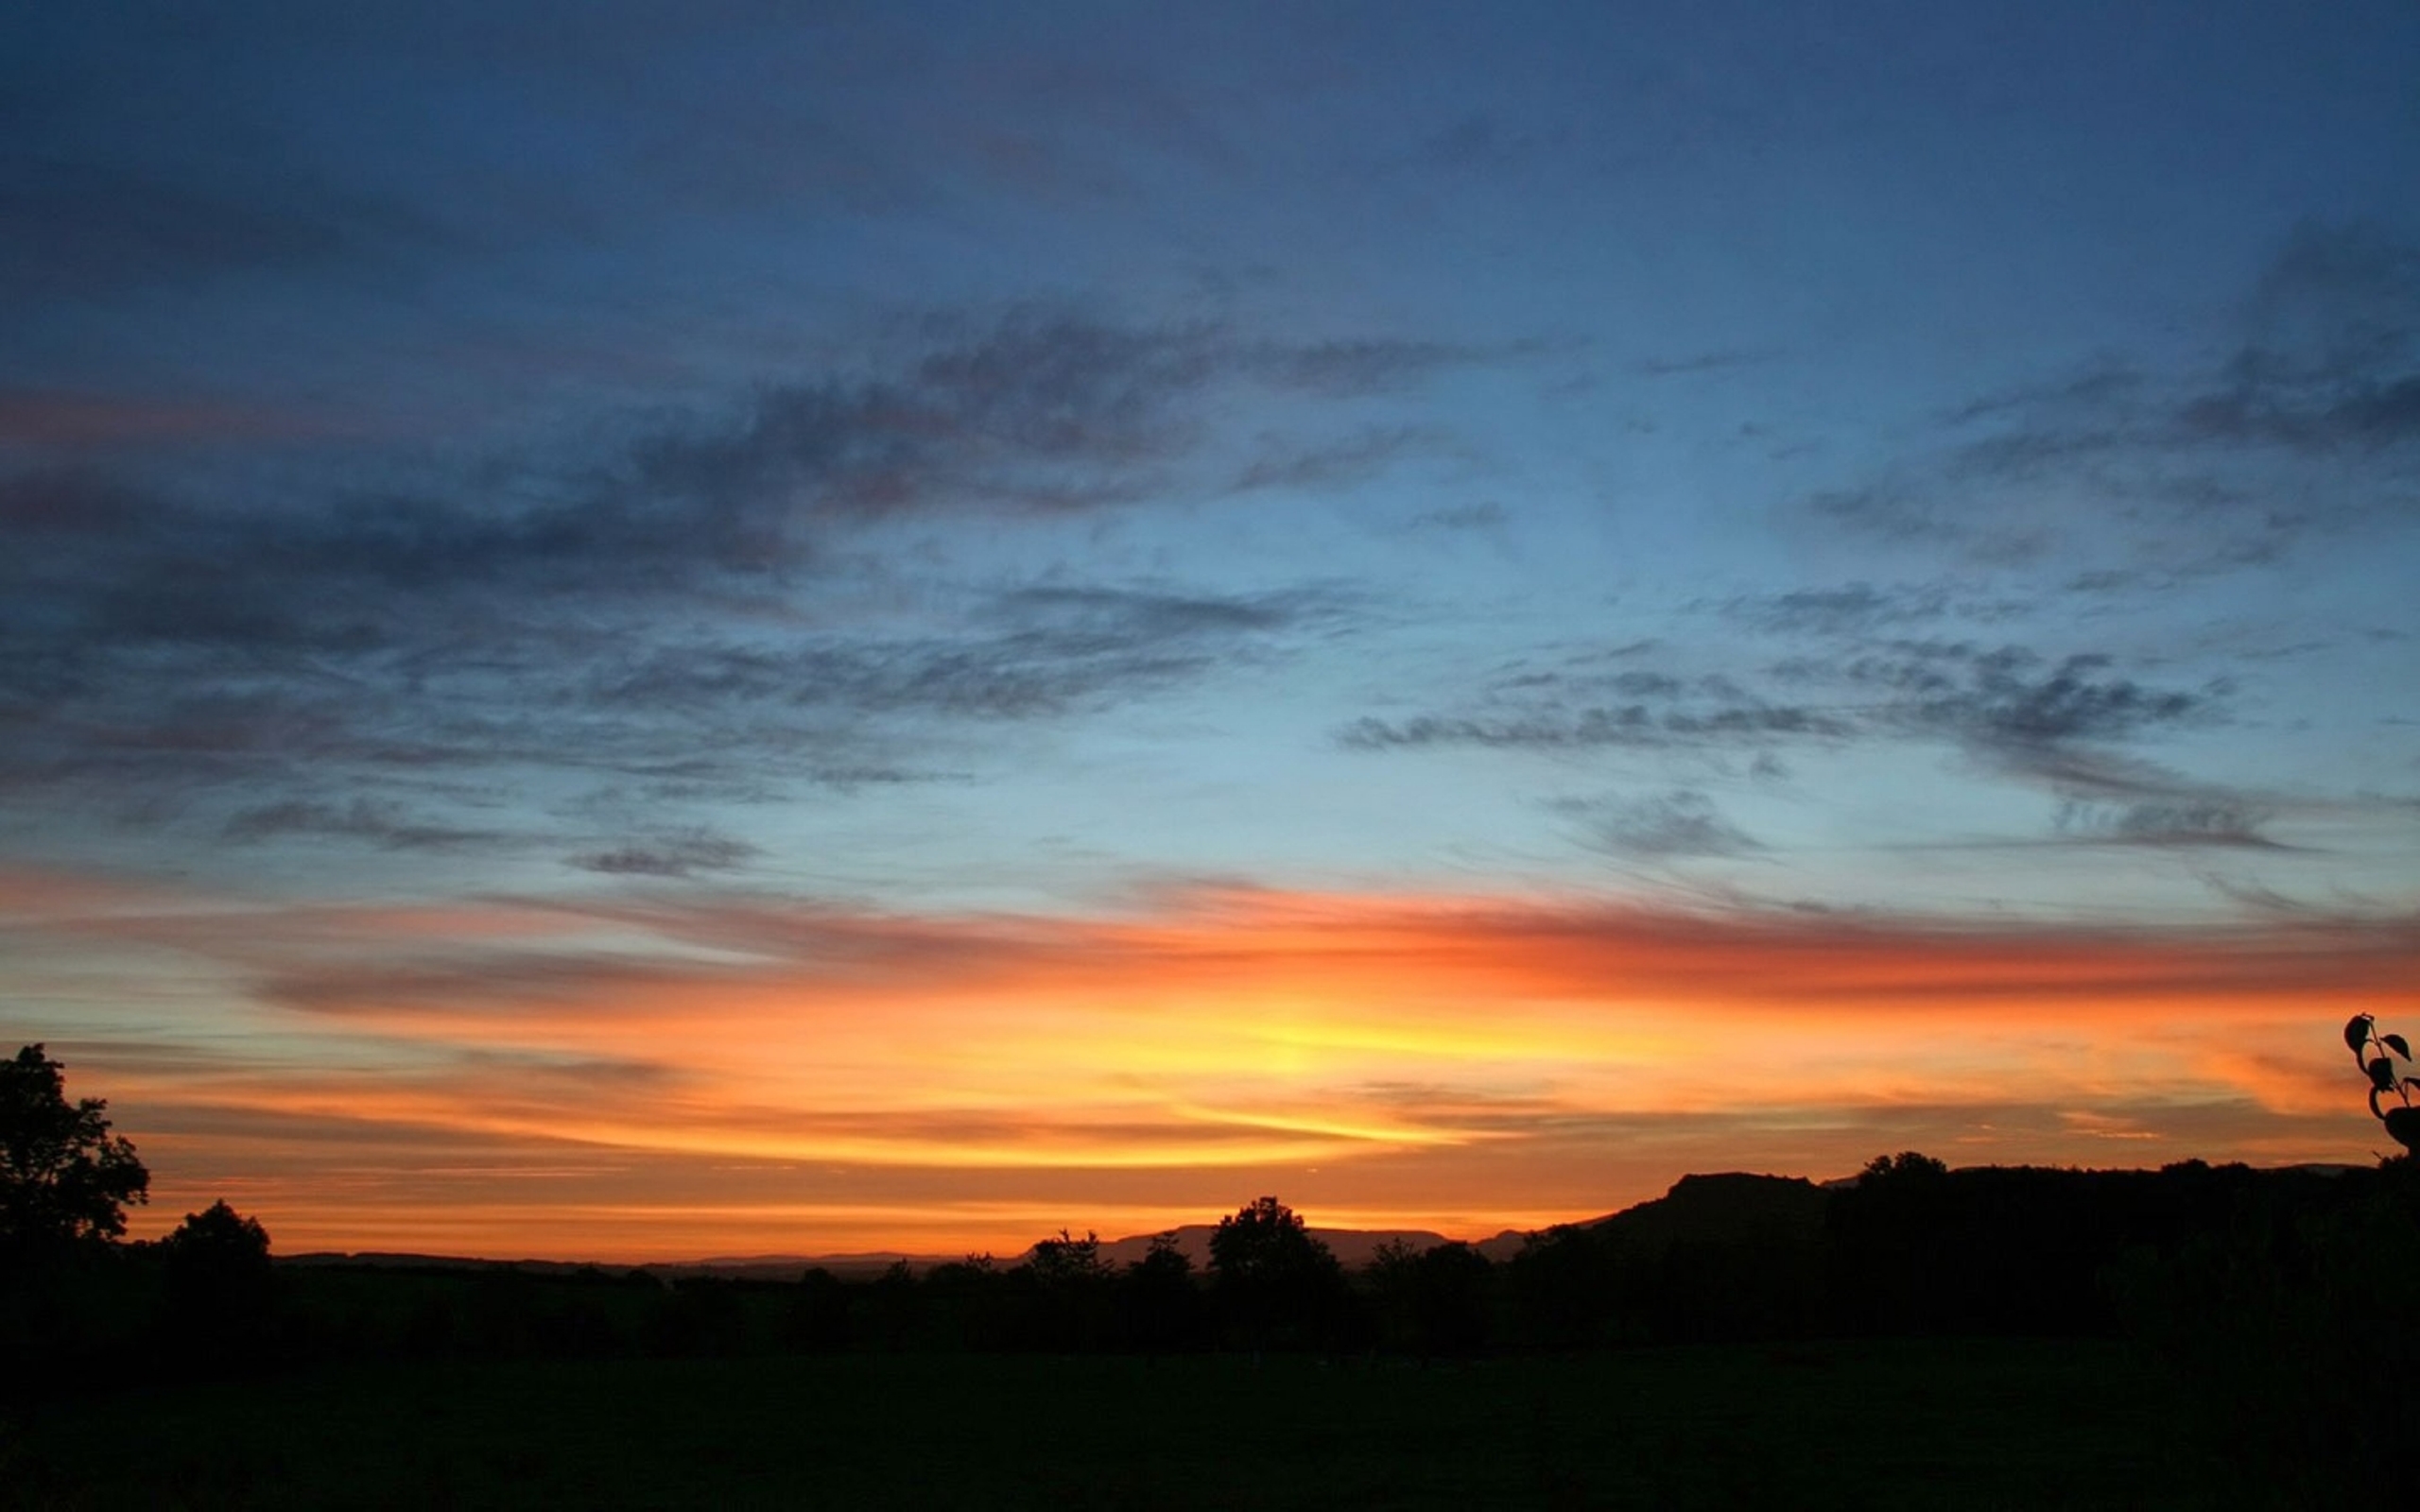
[0,866,2420,1258]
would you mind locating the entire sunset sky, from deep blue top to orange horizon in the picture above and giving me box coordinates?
[0,0,2420,1261]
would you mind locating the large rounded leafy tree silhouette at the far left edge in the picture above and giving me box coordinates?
[0,1045,150,1265]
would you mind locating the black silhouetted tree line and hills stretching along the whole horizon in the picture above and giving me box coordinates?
[0,1016,2420,1486]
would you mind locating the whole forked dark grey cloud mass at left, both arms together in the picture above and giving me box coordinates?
[0,310,1494,856]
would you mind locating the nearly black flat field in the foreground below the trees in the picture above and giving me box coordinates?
[0,1340,2226,1512]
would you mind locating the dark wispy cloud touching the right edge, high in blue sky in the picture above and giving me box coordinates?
[1801,223,2420,580]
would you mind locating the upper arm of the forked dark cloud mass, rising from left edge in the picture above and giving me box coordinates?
[0,312,1490,678]
